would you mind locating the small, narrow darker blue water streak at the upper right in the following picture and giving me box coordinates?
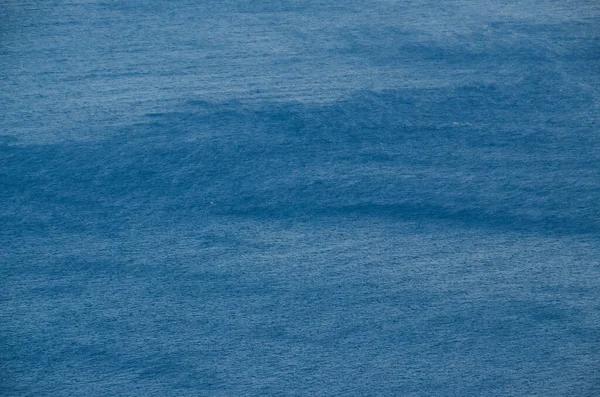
[337,17,598,70]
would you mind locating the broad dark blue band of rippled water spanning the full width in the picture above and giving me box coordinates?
[1,82,600,234]
